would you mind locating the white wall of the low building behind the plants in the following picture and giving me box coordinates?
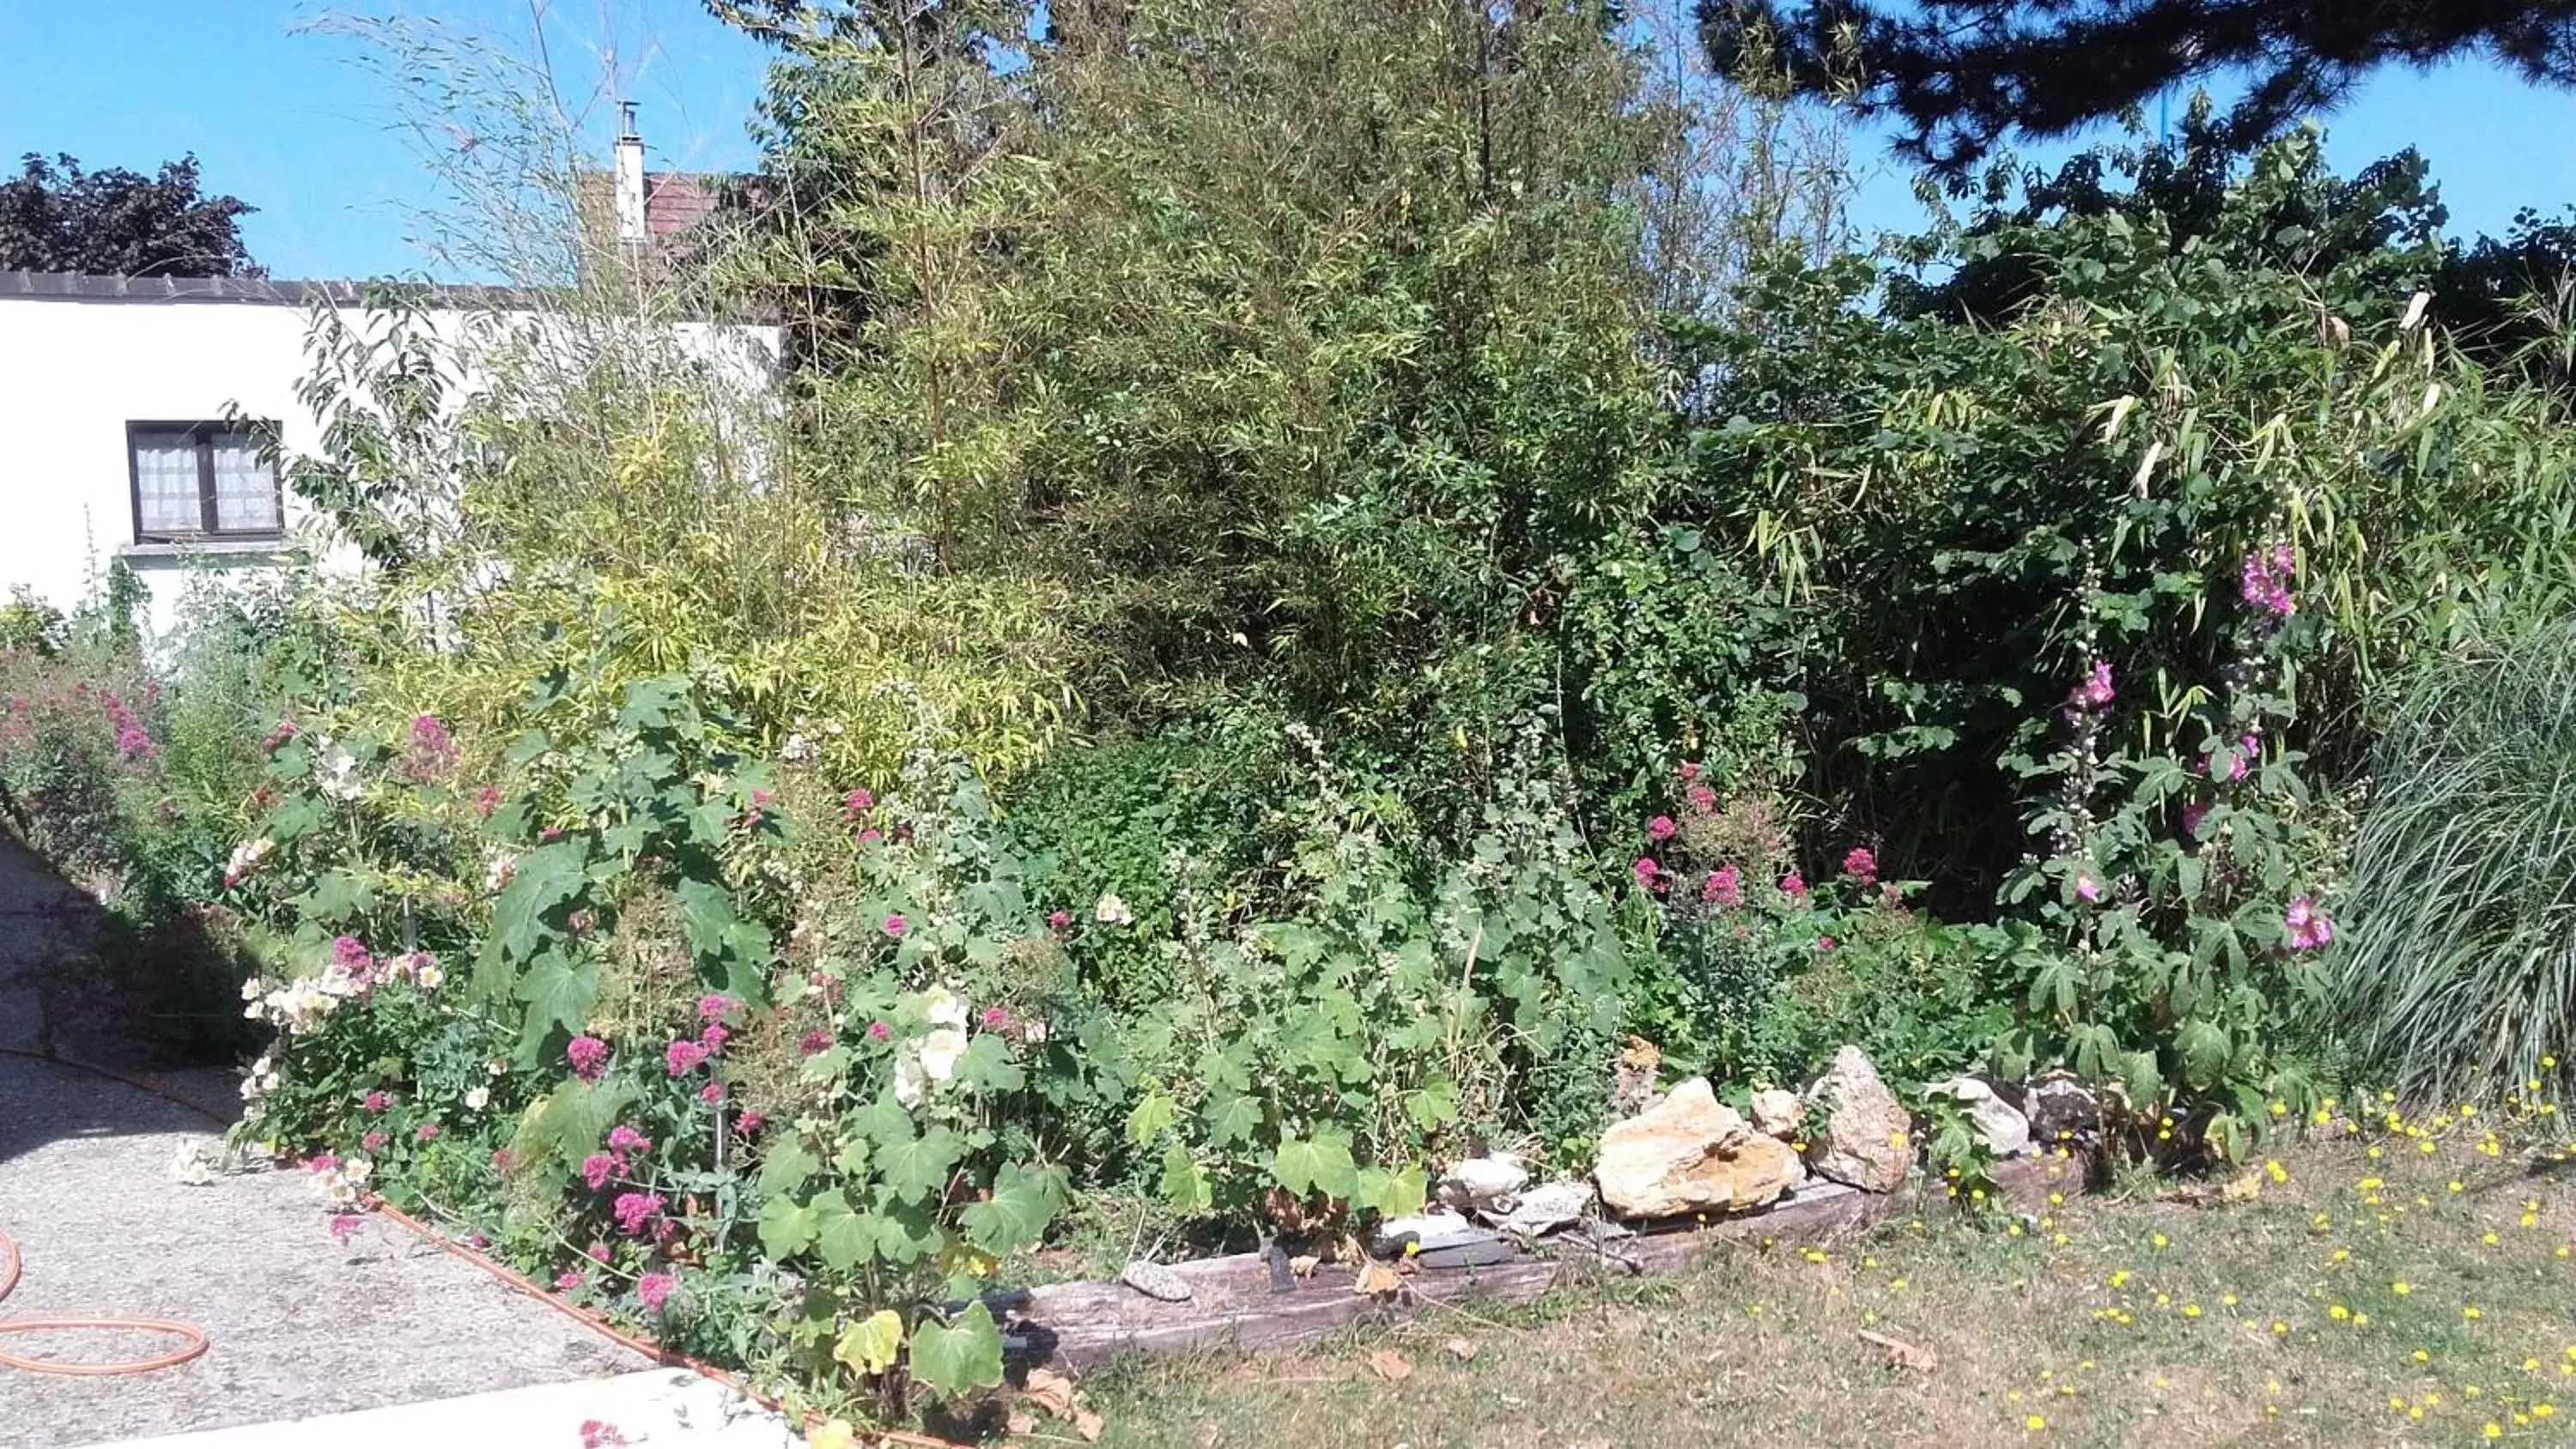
[0,288,778,634]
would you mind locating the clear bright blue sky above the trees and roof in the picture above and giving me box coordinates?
[0,0,2576,278]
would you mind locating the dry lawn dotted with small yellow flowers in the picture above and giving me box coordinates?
[1087,1106,2576,1449]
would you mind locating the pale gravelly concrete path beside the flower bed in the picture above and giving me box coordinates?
[0,1055,649,1449]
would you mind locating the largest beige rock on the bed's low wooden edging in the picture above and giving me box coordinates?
[1592,1076,1806,1217]
